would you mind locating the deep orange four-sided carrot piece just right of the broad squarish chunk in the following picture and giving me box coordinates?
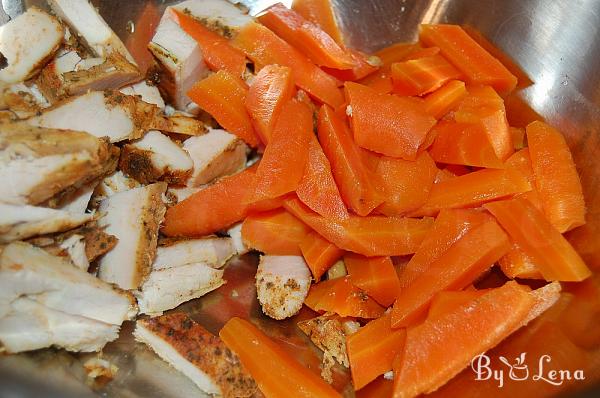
[429,120,504,169]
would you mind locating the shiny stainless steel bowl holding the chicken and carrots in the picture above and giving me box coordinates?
[0,0,600,397]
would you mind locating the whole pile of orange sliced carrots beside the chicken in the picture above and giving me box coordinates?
[163,0,600,397]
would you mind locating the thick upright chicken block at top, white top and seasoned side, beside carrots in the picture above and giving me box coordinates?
[148,9,209,111]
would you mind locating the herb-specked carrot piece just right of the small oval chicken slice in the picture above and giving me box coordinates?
[304,276,385,319]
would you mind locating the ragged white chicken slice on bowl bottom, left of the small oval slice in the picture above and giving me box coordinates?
[134,263,225,315]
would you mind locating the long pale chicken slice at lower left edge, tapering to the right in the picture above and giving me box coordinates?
[0,242,137,325]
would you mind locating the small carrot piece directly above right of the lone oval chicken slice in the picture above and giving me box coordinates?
[300,231,344,281]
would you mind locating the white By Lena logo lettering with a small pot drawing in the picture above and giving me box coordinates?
[471,352,585,388]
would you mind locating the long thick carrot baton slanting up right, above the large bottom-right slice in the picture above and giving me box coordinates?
[392,220,510,328]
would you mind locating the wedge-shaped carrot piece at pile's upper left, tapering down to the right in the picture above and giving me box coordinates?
[188,70,258,147]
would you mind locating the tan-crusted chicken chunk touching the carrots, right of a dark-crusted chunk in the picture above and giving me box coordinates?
[183,129,248,187]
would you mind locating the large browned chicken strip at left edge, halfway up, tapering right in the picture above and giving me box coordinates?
[0,124,116,204]
